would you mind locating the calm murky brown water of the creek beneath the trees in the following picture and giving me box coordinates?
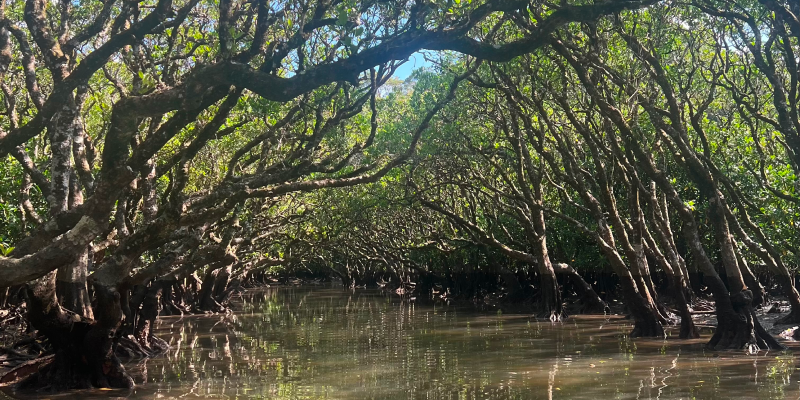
[1,287,800,399]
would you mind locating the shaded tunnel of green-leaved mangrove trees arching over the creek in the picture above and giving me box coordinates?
[0,0,800,391]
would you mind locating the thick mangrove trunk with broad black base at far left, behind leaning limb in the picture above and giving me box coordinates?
[20,86,133,391]
